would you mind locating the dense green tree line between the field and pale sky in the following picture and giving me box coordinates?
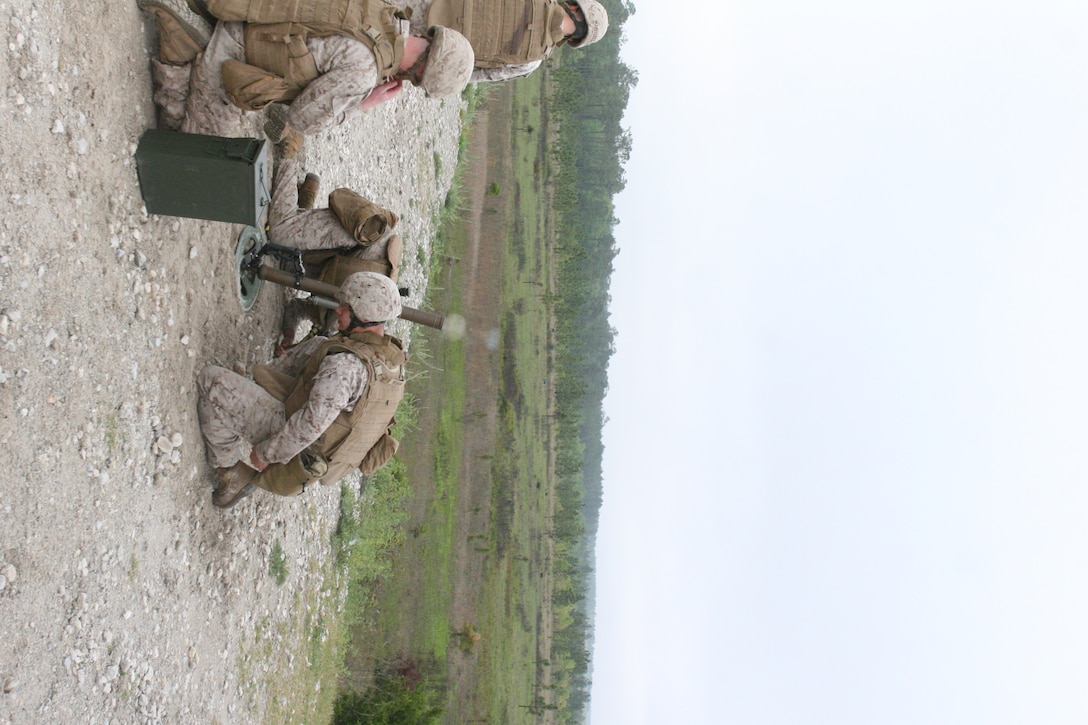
[546,0,638,723]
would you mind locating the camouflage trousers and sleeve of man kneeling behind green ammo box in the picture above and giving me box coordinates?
[151,22,379,136]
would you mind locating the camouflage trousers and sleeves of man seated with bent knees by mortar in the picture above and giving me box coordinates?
[197,337,368,468]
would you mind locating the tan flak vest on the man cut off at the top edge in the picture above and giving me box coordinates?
[426,0,566,67]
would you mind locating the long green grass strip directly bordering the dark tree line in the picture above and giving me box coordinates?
[463,70,551,722]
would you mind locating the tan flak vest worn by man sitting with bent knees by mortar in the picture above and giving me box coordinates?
[254,332,406,483]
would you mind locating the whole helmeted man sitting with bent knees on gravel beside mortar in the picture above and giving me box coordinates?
[197,267,405,507]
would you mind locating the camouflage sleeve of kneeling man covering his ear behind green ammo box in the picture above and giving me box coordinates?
[287,35,378,136]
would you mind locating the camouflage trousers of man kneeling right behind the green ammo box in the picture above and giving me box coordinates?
[151,23,246,136]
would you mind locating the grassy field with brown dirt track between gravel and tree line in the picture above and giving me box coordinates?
[343,74,561,725]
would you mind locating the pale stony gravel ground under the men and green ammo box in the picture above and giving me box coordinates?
[0,0,459,723]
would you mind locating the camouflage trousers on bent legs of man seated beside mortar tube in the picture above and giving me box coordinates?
[197,365,285,468]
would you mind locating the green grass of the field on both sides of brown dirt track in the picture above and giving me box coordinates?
[338,76,558,723]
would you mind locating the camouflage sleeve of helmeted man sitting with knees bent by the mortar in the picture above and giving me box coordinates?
[254,353,368,463]
